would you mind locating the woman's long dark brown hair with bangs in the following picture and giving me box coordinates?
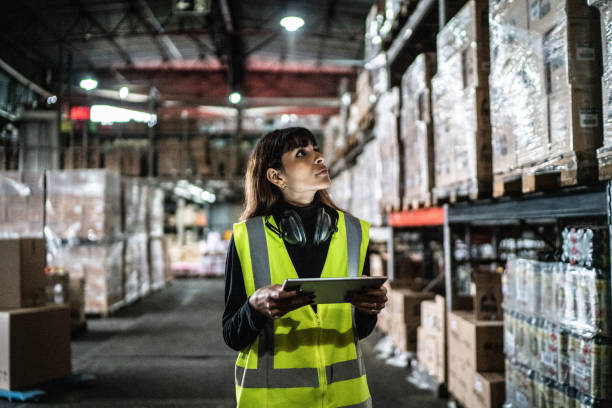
[240,127,339,220]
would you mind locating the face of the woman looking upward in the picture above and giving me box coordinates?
[281,144,331,195]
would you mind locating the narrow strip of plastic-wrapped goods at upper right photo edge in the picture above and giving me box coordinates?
[589,0,612,180]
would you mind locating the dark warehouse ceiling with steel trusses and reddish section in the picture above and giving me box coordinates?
[0,0,372,115]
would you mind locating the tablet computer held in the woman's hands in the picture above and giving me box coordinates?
[283,276,387,304]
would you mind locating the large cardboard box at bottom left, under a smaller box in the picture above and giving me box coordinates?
[0,305,71,390]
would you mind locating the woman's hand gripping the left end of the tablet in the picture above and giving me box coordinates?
[249,285,314,319]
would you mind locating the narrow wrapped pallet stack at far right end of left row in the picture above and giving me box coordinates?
[147,188,170,290]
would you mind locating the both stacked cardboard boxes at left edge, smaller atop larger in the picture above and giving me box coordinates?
[0,238,71,390]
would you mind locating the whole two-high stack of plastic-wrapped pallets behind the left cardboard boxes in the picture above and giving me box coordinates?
[45,170,124,315]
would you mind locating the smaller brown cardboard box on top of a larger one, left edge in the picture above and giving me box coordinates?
[0,238,47,309]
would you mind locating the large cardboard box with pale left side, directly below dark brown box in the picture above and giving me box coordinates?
[448,311,504,372]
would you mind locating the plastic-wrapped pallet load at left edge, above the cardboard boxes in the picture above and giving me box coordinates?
[0,171,44,238]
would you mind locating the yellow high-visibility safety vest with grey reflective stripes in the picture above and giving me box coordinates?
[234,211,372,408]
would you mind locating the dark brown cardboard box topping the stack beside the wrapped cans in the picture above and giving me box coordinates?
[474,272,504,320]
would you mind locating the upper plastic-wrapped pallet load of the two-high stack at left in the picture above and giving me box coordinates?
[46,170,121,241]
